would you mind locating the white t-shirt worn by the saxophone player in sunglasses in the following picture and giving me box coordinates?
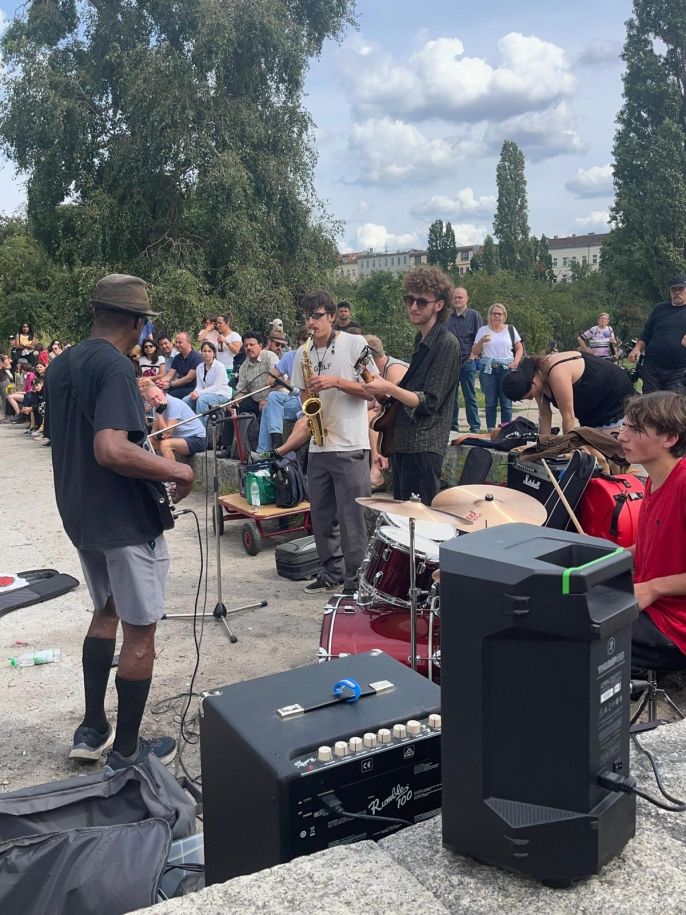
[291,333,378,453]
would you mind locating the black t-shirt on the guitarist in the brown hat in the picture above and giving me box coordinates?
[46,339,162,549]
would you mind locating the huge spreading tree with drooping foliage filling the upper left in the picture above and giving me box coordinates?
[0,0,354,313]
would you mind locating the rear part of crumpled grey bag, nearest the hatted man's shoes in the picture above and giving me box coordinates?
[0,754,195,841]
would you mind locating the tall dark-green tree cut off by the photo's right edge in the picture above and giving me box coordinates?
[601,0,686,301]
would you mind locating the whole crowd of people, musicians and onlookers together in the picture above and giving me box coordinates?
[0,266,686,769]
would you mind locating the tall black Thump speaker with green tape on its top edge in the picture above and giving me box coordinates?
[440,524,638,886]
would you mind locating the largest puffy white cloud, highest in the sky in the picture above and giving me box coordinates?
[344,32,576,122]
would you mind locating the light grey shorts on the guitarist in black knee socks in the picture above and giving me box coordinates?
[78,534,169,626]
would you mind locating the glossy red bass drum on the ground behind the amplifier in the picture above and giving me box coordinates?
[318,596,441,683]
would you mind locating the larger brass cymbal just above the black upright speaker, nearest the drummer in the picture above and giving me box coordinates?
[431,484,547,531]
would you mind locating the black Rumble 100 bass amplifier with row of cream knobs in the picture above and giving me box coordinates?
[200,651,441,884]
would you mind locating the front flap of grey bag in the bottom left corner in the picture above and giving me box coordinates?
[0,817,171,915]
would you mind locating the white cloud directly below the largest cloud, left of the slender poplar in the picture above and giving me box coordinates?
[349,118,478,184]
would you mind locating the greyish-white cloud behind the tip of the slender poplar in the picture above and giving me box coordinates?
[484,102,587,162]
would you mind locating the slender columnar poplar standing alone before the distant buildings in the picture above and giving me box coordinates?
[493,140,533,276]
